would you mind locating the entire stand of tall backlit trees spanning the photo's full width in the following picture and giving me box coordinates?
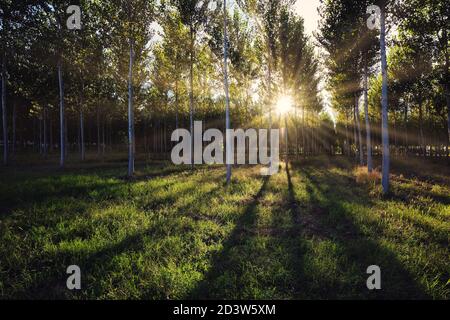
[0,0,450,192]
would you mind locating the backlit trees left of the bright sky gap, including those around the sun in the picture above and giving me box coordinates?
[1,0,321,175]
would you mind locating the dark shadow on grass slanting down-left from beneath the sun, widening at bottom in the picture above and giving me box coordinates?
[187,177,269,299]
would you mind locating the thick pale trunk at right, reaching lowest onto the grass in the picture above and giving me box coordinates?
[380,6,390,194]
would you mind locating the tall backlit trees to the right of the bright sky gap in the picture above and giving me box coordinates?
[317,0,450,193]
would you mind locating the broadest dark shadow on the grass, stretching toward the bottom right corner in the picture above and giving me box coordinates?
[299,168,430,299]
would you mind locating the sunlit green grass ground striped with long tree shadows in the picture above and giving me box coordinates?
[0,157,450,299]
